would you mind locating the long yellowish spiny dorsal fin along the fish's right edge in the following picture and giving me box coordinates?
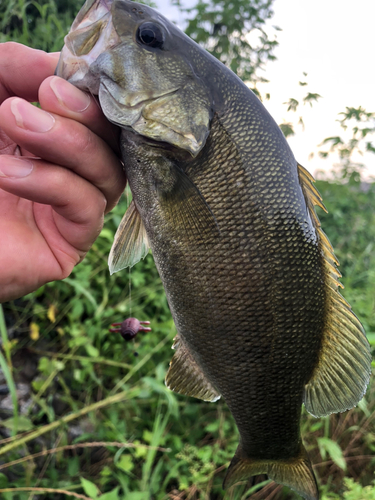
[298,165,371,417]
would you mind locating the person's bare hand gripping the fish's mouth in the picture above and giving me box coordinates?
[0,42,126,303]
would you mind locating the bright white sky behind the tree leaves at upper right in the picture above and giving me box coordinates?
[156,0,375,179]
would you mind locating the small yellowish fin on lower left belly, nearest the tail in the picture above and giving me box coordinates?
[165,335,220,402]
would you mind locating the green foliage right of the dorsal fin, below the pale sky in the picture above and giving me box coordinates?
[317,173,375,339]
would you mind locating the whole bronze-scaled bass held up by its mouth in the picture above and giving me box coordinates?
[56,0,371,500]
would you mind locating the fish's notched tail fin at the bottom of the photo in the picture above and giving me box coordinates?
[223,444,319,500]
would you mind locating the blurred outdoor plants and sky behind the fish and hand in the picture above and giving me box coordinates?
[0,0,375,500]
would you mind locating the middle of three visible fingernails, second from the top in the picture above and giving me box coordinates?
[10,98,55,132]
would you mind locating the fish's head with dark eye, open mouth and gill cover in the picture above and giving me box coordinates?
[56,0,213,156]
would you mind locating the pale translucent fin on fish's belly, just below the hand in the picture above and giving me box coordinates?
[108,200,149,274]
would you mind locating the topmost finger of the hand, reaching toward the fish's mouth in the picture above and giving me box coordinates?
[0,42,59,103]
